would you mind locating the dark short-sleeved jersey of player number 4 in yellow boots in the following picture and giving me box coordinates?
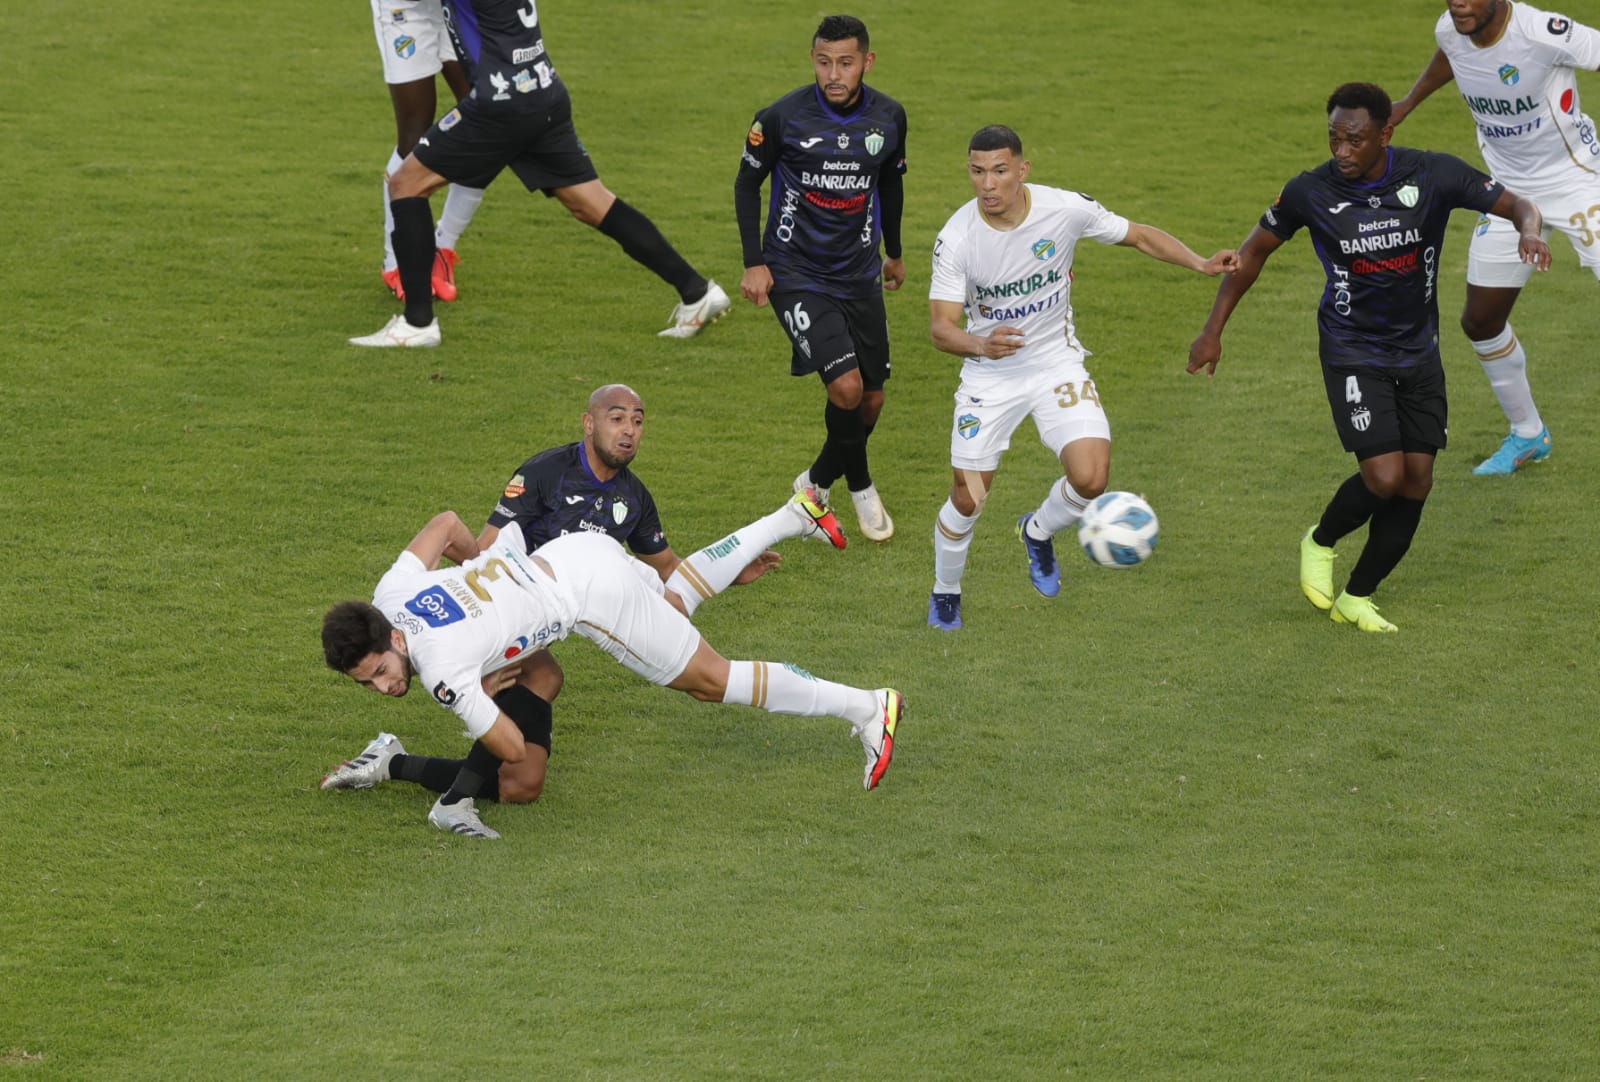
[1261,147,1506,368]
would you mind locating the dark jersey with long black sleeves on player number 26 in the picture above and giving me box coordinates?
[733,83,906,298]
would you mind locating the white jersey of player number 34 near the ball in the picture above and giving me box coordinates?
[928,184,1128,381]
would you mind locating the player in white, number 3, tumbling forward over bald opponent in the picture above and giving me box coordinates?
[322,511,906,837]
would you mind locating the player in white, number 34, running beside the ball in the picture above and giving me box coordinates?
[928,125,1237,631]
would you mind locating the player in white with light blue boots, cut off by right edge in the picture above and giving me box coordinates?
[1389,0,1600,475]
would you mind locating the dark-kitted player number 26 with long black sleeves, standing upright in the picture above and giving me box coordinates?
[733,14,906,541]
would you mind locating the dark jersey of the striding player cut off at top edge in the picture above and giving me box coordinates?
[443,0,566,112]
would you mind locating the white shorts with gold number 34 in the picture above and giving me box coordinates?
[950,360,1110,471]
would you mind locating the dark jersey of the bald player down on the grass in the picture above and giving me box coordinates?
[490,442,667,555]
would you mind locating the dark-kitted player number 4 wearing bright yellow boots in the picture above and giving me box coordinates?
[1189,83,1550,632]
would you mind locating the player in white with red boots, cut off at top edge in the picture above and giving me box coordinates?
[371,0,483,301]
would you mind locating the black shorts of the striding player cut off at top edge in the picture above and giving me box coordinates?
[413,94,600,195]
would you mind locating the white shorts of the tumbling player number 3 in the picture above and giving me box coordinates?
[534,533,701,685]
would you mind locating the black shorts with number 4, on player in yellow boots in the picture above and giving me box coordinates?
[1322,357,1450,459]
